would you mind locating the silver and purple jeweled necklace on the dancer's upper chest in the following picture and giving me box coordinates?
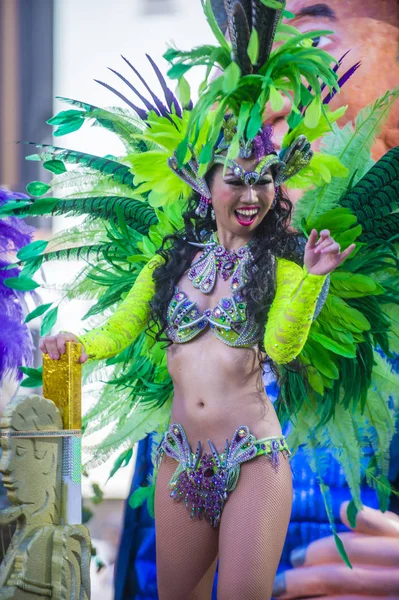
[188,233,252,294]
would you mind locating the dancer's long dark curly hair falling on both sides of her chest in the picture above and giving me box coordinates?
[148,167,302,372]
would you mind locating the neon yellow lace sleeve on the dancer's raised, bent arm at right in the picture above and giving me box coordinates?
[264,258,326,364]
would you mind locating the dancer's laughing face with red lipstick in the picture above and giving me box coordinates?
[210,158,275,237]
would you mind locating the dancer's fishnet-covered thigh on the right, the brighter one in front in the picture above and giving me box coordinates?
[218,456,292,600]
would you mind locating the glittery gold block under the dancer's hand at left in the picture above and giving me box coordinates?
[43,342,82,429]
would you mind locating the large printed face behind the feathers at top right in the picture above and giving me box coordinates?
[274,0,399,159]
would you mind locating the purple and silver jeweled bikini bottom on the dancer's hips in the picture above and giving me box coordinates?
[157,423,290,527]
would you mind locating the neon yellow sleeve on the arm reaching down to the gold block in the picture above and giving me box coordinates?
[78,256,163,360]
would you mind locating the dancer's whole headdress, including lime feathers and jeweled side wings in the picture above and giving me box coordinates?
[128,0,350,206]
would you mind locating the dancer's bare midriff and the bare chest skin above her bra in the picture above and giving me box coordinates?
[167,278,281,452]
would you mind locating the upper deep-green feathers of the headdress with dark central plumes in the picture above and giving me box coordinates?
[164,0,339,175]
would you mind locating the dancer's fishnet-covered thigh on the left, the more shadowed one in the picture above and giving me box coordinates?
[155,455,218,600]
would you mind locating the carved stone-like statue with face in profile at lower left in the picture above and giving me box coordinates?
[0,395,90,600]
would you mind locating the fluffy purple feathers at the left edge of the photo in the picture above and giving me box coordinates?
[0,188,34,381]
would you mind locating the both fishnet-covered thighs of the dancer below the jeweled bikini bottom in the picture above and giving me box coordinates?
[155,455,292,600]
